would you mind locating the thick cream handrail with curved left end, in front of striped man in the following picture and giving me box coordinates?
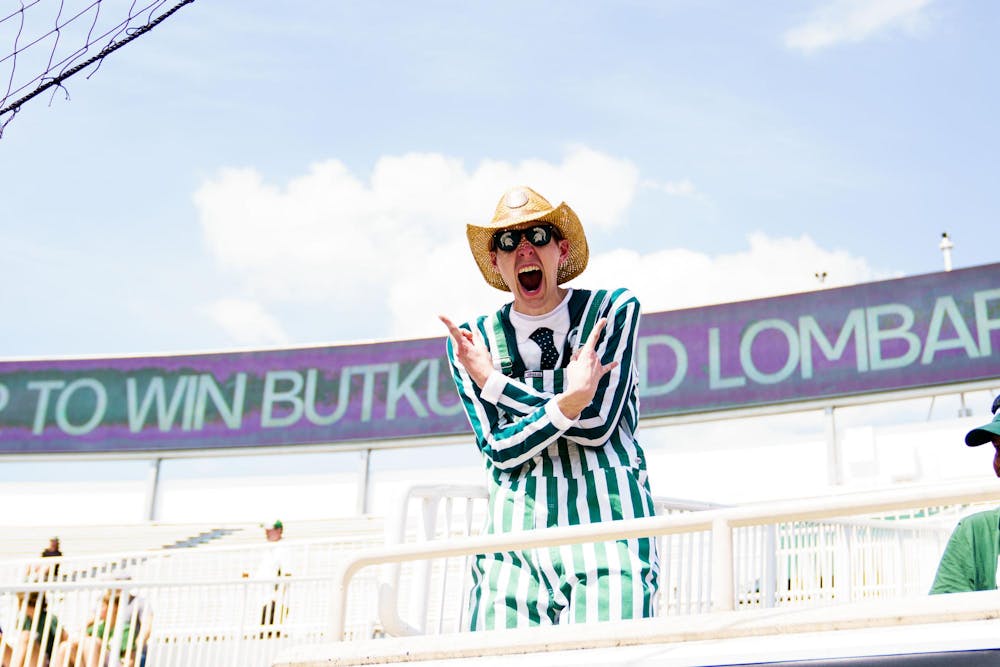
[331,480,1000,641]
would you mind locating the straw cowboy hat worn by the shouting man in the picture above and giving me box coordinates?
[465,186,590,292]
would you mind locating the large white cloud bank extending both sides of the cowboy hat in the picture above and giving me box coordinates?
[196,147,887,344]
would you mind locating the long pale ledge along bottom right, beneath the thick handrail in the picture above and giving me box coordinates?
[273,591,1000,667]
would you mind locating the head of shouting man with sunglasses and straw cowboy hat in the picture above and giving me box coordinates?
[466,186,590,315]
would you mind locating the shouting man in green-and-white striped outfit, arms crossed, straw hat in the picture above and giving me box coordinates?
[441,187,659,630]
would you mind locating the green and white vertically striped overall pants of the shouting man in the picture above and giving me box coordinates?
[470,465,659,630]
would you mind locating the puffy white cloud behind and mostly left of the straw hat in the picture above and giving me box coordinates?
[194,146,639,342]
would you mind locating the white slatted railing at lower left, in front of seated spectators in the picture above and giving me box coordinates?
[0,530,384,667]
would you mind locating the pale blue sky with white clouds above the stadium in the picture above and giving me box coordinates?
[0,0,1000,358]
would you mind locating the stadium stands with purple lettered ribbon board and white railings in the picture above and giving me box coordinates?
[0,264,1000,667]
